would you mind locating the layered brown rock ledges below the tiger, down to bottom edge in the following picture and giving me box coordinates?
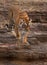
[0,23,47,65]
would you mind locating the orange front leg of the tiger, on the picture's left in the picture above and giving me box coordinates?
[14,15,21,39]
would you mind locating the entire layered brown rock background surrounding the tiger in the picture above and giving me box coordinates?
[0,0,47,65]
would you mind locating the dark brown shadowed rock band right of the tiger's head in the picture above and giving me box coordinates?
[28,11,47,23]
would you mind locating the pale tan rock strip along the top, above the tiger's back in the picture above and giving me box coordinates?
[0,0,47,11]
